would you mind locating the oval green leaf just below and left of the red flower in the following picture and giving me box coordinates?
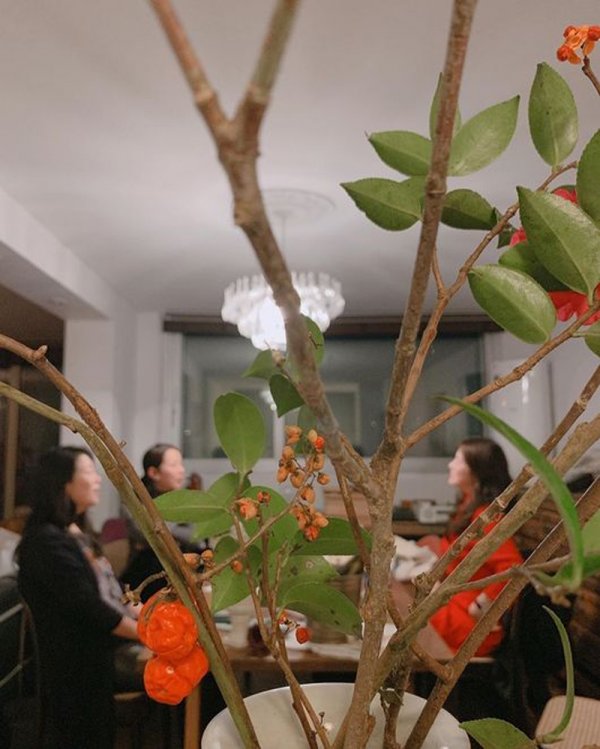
[469,265,556,343]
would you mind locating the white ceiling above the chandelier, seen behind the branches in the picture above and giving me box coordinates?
[0,0,600,324]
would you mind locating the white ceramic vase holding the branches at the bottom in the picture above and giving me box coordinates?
[201,683,470,749]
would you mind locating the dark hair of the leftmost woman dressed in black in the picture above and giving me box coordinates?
[27,447,92,528]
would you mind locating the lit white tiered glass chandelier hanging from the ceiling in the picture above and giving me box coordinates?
[221,272,345,351]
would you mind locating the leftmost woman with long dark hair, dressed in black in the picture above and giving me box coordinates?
[17,447,137,749]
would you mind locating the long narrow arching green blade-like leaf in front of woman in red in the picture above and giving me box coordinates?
[441,395,583,590]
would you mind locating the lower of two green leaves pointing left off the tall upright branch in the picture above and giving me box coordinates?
[342,177,425,231]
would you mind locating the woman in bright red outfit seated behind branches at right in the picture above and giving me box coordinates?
[424,437,523,655]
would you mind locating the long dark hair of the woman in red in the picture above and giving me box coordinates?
[447,437,512,533]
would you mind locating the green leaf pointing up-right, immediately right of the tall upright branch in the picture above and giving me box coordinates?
[448,96,519,177]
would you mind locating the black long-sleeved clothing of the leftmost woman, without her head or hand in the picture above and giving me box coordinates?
[18,524,121,749]
